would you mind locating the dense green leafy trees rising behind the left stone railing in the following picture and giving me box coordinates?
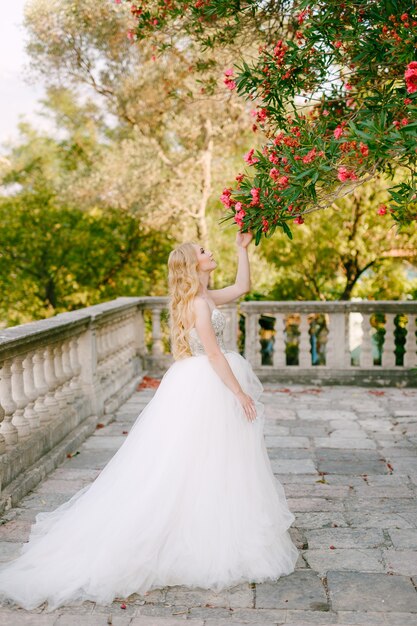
[0,194,171,325]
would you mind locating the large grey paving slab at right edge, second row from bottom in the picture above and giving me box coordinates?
[327,571,417,612]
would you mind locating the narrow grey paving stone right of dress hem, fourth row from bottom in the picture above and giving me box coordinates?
[304,528,384,550]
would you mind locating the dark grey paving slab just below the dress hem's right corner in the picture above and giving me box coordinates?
[256,570,328,611]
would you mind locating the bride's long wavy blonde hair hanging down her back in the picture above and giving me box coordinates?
[168,242,200,360]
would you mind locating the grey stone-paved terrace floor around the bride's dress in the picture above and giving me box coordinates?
[0,384,417,626]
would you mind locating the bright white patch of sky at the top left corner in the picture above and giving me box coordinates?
[0,0,45,145]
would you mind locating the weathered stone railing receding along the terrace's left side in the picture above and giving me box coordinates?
[0,298,144,511]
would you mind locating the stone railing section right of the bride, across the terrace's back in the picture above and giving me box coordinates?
[240,301,417,386]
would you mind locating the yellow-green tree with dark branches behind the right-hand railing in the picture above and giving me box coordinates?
[262,181,417,300]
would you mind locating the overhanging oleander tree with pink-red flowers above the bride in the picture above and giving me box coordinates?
[124,0,417,243]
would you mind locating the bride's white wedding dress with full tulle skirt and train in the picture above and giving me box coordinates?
[0,309,298,611]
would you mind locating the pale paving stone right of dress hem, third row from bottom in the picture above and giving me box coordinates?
[303,544,385,573]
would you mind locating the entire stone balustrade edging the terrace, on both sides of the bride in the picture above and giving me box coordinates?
[0,297,417,511]
